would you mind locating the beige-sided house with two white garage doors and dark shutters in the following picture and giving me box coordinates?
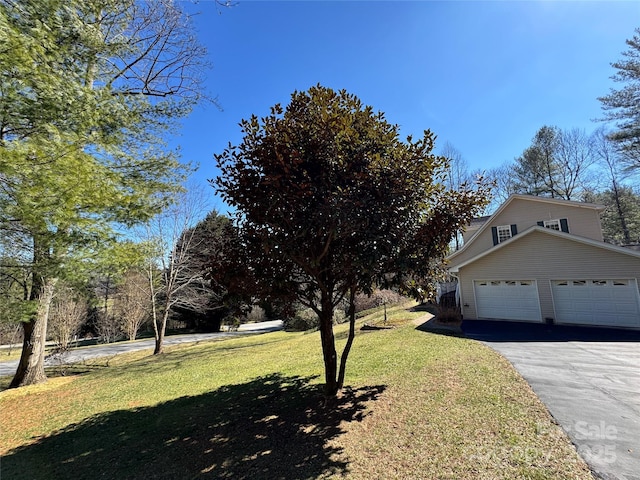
[447,195,640,329]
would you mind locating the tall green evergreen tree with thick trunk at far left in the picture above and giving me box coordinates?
[0,0,204,386]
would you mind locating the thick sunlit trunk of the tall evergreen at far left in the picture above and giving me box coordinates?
[9,275,56,388]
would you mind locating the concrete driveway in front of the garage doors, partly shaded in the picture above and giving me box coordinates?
[462,321,640,480]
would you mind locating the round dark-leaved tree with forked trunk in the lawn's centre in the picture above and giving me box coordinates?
[213,85,488,396]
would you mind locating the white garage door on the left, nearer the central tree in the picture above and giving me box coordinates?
[473,280,542,322]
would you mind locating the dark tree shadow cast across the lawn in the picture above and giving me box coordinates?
[2,374,385,480]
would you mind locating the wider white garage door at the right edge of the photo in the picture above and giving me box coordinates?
[551,279,640,327]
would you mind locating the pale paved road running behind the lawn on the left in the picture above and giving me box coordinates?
[0,320,282,376]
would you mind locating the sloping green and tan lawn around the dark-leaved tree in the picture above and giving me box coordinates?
[0,308,592,480]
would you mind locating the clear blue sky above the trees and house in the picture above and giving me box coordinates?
[172,1,640,204]
